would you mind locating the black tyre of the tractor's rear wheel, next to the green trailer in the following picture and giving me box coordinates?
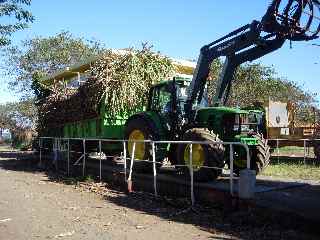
[124,117,163,173]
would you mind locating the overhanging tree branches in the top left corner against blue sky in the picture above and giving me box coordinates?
[0,0,34,46]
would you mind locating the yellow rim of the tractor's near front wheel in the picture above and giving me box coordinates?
[184,144,205,171]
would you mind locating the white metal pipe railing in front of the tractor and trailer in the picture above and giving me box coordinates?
[39,137,251,205]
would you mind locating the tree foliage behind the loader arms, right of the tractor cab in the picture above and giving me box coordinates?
[208,61,316,122]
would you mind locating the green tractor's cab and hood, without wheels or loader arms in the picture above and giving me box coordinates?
[147,78,258,144]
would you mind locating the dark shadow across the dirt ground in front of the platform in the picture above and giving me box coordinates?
[0,147,319,239]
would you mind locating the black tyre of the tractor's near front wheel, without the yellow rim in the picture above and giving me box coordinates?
[177,128,225,182]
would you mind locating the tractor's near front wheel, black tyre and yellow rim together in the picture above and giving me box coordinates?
[177,128,225,182]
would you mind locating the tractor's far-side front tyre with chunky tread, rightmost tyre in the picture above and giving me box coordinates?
[251,134,270,174]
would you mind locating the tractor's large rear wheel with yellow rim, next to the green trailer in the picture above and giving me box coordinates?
[124,117,162,173]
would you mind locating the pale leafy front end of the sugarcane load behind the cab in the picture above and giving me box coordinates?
[92,45,173,119]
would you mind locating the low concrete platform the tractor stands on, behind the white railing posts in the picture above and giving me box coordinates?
[53,156,320,223]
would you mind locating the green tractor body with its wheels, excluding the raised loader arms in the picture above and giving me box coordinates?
[124,76,270,181]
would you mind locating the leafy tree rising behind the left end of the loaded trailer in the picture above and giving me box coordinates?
[4,31,103,98]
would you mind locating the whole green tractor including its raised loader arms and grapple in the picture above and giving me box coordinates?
[124,0,317,180]
